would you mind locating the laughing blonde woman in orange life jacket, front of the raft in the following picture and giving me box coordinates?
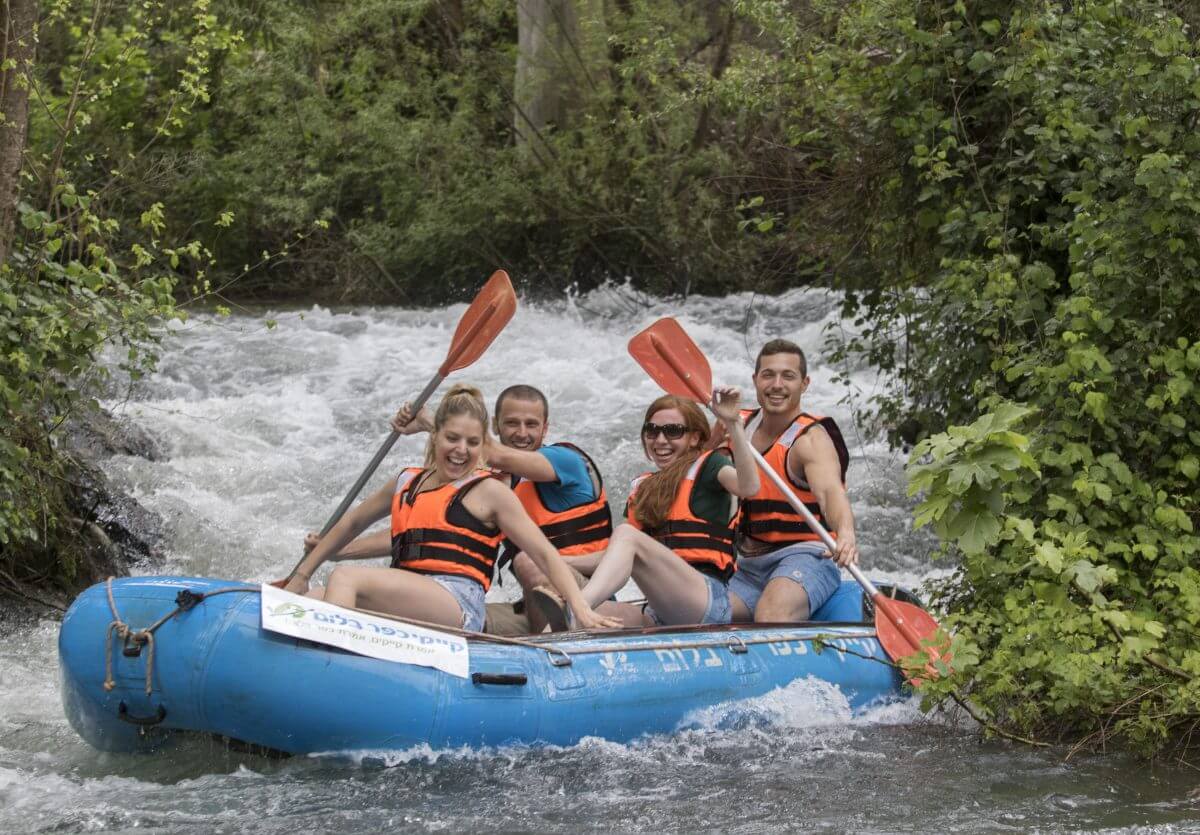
[287,385,618,631]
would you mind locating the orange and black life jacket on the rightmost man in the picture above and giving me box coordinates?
[738,409,850,546]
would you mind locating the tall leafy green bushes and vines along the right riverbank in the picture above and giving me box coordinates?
[734,1,1200,751]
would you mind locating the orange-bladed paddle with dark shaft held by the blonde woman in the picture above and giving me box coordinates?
[272,270,517,588]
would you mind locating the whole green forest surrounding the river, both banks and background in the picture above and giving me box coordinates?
[0,0,1200,756]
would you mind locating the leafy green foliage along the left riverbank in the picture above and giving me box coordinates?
[0,0,242,583]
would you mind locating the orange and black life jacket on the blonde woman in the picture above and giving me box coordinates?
[391,467,503,591]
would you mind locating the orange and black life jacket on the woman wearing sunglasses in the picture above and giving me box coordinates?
[625,450,737,582]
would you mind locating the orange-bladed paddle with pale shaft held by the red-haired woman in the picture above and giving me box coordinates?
[629,317,948,684]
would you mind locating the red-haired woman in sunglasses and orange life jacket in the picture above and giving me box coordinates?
[535,388,758,629]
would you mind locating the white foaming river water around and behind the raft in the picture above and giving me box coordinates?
[0,287,1200,833]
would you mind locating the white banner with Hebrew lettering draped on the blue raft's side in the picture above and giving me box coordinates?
[262,583,469,678]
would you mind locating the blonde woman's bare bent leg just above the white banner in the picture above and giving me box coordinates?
[325,565,462,627]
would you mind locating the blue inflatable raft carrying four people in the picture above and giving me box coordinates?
[59,577,911,753]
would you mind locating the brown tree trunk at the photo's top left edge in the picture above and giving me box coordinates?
[0,0,37,264]
